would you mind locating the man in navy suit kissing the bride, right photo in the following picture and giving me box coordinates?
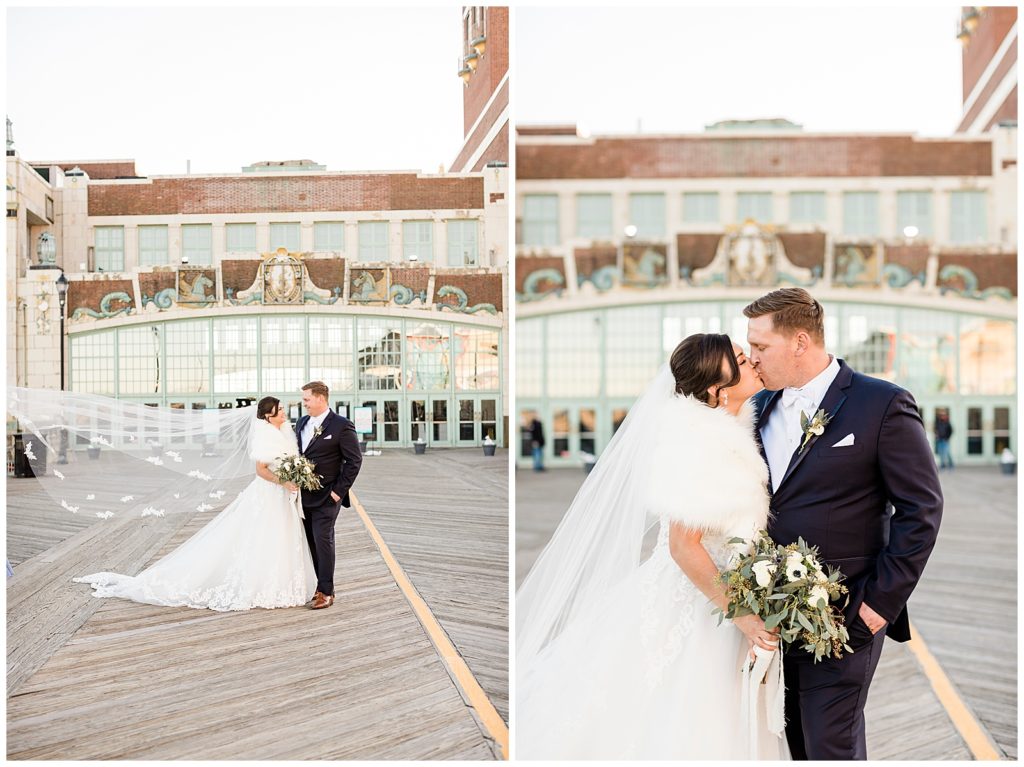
[743,288,942,760]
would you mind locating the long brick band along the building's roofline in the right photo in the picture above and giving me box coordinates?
[516,136,992,179]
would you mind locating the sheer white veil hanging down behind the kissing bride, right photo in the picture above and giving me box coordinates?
[516,365,685,675]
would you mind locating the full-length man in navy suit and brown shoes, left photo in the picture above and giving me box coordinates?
[295,381,362,610]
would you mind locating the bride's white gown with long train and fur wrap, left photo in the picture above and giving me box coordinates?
[74,420,316,611]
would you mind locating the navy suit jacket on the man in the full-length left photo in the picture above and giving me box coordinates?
[295,411,362,508]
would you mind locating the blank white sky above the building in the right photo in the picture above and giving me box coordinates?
[514,4,962,135]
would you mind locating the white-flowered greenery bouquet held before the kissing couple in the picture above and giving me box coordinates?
[715,530,853,663]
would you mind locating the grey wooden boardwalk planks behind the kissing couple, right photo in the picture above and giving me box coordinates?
[516,467,1017,761]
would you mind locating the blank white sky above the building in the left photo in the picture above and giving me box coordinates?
[6,5,463,175]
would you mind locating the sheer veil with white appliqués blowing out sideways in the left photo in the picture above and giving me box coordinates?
[7,387,268,519]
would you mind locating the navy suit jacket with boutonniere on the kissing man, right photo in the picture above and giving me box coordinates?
[754,359,942,648]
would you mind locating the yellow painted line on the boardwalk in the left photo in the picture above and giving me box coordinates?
[348,491,509,759]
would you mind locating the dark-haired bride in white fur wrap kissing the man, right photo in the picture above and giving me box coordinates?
[516,334,790,760]
